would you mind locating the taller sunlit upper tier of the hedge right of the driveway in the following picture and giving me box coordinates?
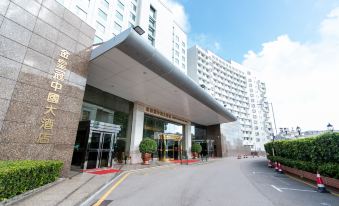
[265,133,339,164]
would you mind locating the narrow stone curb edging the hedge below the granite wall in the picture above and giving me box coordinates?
[0,178,66,206]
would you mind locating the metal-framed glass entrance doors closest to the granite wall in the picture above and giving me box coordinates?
[84,131,115,169]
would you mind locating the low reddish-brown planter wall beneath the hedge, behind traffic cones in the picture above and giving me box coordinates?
[282,165,339,189]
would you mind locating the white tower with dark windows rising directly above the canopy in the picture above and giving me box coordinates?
[57,0,187,74]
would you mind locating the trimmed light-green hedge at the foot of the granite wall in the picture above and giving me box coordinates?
[0,160,63,201]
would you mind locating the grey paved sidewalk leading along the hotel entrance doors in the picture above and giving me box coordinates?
[5,161,199,206]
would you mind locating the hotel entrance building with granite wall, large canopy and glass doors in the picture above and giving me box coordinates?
[0,0,239,176]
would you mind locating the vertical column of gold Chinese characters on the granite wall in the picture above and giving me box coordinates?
[37,49,70,144]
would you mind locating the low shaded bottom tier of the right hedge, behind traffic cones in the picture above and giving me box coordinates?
[267,155,339,179]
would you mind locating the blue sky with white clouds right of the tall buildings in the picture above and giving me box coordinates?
[165,0,339,130]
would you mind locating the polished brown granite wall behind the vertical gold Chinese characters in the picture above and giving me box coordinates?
[0,0,95,176]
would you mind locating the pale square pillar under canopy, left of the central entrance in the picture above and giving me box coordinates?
[130,103,145,164]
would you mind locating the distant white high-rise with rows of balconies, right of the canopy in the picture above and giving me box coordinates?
[187,46,272,151]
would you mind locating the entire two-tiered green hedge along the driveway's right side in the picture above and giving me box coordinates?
[265,132,339,179]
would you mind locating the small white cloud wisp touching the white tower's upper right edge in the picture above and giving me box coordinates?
[161,0,191,32]
